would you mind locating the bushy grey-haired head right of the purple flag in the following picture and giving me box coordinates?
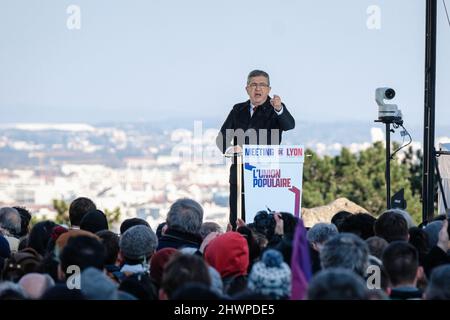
[320,233,369,277]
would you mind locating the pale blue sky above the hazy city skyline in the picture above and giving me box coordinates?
[0,0,450,126]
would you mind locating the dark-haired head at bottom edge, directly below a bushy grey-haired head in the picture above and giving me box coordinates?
[307,268,368,300]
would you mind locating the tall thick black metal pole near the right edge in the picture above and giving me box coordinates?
[422,0,437,221]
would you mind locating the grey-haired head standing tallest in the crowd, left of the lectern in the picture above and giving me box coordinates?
[166,198,203,234]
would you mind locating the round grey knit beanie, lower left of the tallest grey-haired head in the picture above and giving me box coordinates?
[119,225,158,260]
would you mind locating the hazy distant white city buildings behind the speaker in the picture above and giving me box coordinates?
[0,123,448,229]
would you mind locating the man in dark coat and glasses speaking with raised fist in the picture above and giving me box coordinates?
[216,70,295,229]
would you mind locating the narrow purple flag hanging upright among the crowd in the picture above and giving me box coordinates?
[291,219,312,300]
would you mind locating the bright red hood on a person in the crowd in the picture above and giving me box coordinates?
[204,231,249,278]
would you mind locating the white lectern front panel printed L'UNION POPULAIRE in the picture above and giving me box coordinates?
[242,145,304,223]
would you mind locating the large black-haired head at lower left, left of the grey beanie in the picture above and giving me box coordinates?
[59,236,105,278]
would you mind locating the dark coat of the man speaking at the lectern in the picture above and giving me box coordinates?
[216,97,295,183]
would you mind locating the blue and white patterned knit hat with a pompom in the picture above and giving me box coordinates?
[248,249,291,299]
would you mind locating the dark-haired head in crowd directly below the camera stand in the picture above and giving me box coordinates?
[374,210,409,242]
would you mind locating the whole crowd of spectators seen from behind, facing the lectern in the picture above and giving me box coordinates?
[0,197,450,300]
